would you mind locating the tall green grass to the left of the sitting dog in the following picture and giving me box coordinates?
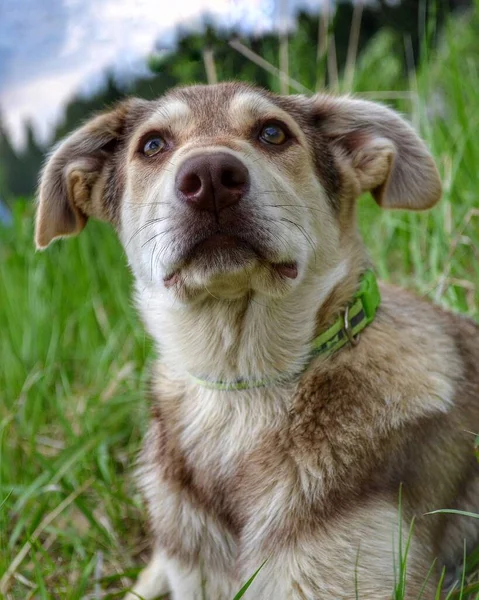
[0,205,150,599]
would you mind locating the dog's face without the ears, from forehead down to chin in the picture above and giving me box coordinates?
[120,86,338,298]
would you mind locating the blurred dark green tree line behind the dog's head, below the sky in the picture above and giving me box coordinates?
[0,0,470,203]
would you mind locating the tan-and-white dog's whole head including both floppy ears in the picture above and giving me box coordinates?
[36,84,441,301]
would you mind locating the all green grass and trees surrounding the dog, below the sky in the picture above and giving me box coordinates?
[0,2,479,600]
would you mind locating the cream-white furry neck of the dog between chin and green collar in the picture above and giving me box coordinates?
[139,253,366,381]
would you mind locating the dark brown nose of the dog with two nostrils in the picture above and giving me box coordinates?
[176,152,249,214]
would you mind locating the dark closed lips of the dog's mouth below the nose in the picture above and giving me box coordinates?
[163,233,298,288]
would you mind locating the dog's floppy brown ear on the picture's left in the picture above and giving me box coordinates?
[35,98,146,248]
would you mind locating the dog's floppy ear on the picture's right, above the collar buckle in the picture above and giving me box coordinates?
[312,96,441,210]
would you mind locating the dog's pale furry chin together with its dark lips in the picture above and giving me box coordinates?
[163,234,298,301]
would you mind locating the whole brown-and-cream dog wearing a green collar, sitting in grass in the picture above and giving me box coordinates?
[35,83,479,600]
